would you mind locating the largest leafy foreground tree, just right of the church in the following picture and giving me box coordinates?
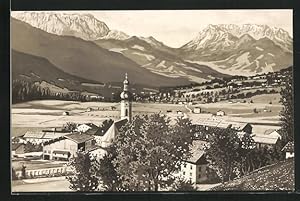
[109,114,193,191]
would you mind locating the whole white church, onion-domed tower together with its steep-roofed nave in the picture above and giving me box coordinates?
[100,73,132,147]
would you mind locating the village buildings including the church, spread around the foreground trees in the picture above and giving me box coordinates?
[11,74,294,191]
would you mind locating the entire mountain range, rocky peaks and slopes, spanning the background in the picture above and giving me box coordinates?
[11,12,293,94]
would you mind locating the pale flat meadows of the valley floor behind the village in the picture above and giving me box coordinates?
[11,94,282,136]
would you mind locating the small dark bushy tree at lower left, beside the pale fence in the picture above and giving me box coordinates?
[67,151,99,192]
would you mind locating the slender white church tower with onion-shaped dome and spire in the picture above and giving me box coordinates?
[120,73,132,122]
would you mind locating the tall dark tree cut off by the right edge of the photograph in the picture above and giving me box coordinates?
[280,75,294,143]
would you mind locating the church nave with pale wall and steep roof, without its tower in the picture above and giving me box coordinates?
[99,119,128,147]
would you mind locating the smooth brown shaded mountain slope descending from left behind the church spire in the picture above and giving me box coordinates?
[11,19,190,86]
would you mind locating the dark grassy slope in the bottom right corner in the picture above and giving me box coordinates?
[210,158,295,191]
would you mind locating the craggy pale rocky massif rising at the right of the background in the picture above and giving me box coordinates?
[179,24,293,75]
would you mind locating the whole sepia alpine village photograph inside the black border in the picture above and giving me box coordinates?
[10,9,295,193]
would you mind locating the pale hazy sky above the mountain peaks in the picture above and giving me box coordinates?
[17,9,293,47]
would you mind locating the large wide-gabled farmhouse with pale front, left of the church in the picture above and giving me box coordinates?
[43,133,94,160]
